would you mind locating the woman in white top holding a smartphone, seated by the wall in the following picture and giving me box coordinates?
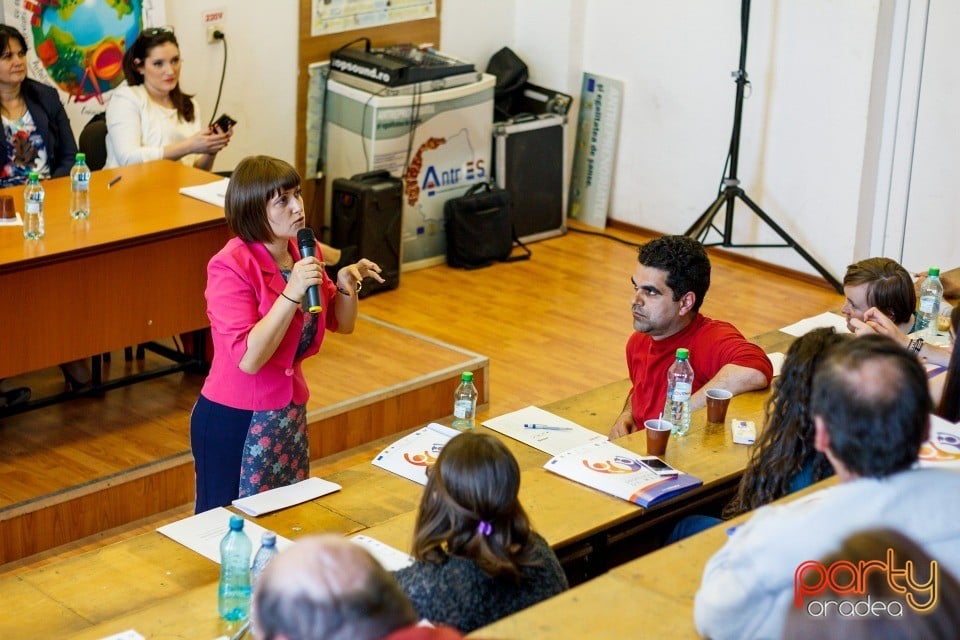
[105,27,233,171]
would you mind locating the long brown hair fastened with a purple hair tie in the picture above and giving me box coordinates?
[413,432,536,581]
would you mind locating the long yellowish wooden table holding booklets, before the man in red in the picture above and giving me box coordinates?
[0,336,796,638]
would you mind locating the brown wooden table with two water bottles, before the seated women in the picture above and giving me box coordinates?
[0,160,229,378]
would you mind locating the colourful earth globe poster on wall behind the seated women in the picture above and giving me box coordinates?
[0,0,164,127]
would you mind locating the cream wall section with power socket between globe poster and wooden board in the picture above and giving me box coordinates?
[166,0,299,171]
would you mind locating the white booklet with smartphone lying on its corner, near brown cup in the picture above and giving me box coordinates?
[543,441,703,507]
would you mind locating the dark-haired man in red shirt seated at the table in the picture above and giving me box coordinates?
[610,236,773,438]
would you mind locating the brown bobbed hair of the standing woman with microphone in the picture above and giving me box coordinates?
[224,156,300,242]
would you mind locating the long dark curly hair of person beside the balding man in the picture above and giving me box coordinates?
[723,327,849,518]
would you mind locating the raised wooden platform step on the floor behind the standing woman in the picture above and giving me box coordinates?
[0,316,489,564]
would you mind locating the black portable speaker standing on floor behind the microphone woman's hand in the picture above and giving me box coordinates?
[330,171,403,298]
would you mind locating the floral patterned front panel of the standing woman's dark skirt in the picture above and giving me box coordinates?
[240,402,310,498]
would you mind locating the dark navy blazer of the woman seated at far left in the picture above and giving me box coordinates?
[6,78,77,178]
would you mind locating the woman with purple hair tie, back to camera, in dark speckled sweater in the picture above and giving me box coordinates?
[396,432,567,633]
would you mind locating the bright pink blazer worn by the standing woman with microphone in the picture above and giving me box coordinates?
[200,238,337,411]
